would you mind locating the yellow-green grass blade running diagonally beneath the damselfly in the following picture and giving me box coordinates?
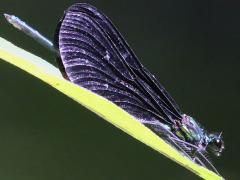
[0,38,223,180]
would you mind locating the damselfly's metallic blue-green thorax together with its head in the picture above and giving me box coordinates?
[173,114,224,156]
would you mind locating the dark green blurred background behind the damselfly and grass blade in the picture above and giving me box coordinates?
[0,0,240,180]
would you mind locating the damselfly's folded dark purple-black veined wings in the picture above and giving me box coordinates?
[55,3,182,125]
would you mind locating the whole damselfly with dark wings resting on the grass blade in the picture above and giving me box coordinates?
[5,3,224,174]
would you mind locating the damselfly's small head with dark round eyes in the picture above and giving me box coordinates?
[208,133,224,156]
